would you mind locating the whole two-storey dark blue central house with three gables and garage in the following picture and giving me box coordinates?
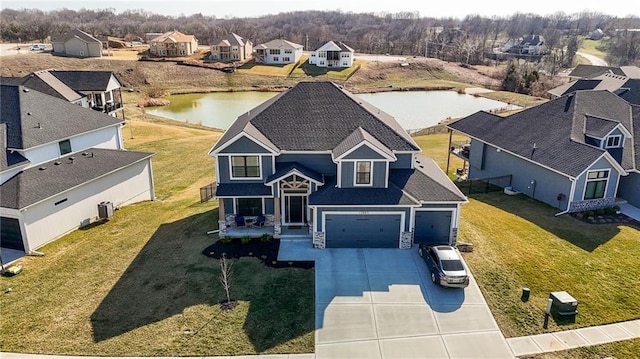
[209,82,466,248]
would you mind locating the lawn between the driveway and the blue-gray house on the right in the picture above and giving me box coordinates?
[460,192,640,337]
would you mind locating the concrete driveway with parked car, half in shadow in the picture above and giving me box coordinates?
[314,249,513,359]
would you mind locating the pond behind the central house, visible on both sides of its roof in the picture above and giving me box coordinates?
[147,91,517,131]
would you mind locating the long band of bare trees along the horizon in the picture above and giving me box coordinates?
[0,8,640,67]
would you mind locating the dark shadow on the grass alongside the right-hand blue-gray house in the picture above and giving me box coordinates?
[469,192,620,252]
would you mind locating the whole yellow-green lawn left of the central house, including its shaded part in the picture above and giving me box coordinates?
[0,110,314,356]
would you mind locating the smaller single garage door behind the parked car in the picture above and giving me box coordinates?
[413,211,452,244]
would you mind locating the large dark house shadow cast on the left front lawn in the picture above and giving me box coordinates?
[91,209,313,352]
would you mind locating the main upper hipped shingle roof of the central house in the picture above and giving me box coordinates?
[213,82,419,151]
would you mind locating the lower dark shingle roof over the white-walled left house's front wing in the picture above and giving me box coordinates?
[0,148,153,209]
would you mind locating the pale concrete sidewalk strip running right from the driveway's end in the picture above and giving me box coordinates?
[507,319,640,357]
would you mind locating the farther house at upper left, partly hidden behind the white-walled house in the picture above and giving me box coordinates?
[0,69,124,118]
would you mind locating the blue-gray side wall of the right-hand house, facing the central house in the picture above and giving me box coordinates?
[469,141,571,209]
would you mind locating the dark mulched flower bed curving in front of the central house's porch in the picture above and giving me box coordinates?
[202,238,315,269]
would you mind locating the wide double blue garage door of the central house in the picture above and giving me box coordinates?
[325,214,401,248]
